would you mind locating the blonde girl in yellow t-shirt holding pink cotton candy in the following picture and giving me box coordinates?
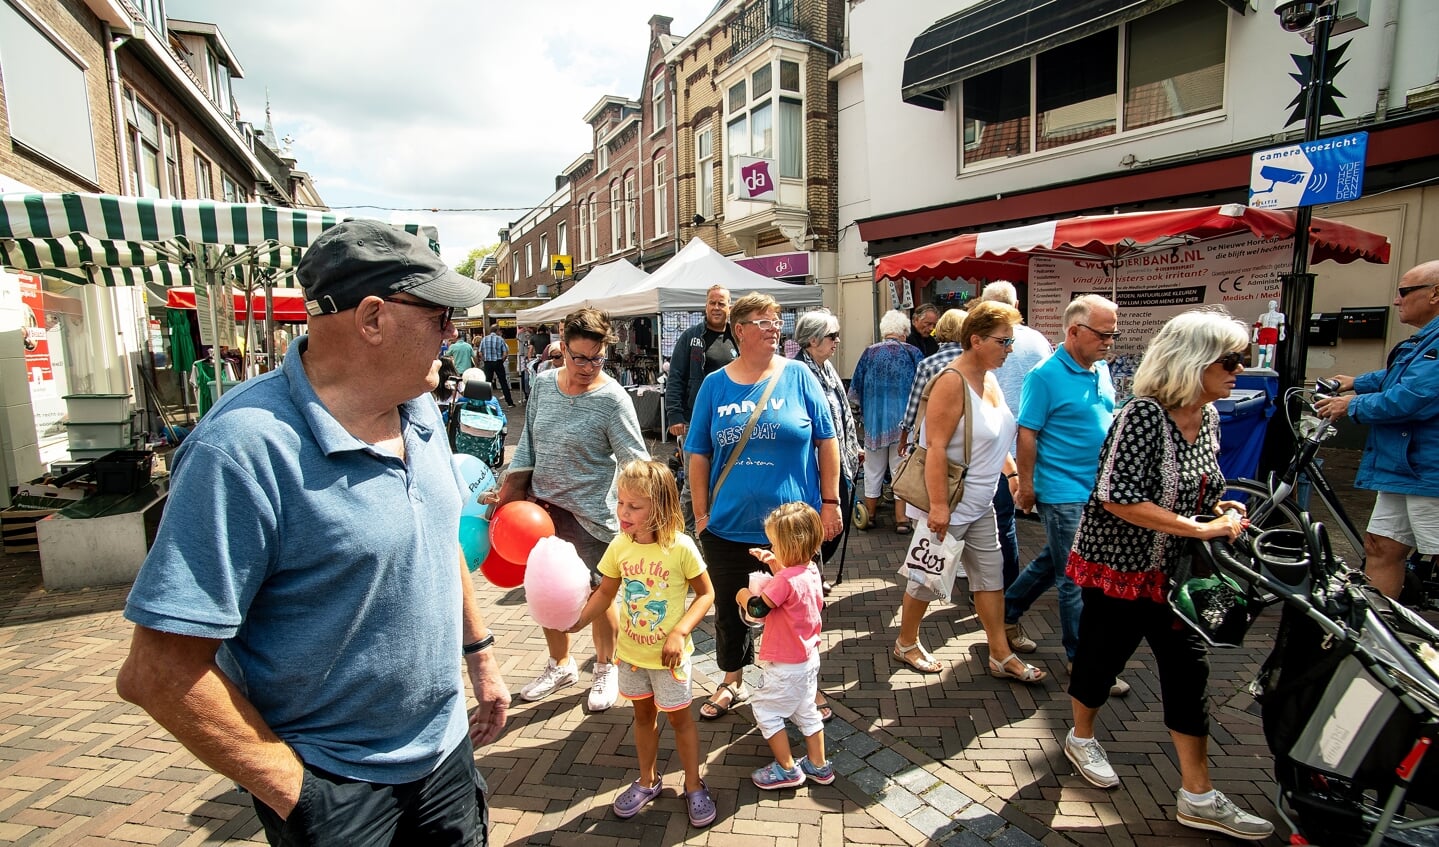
[570,460,717,827]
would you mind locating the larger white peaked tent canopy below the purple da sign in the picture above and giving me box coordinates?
[604,239,820,318]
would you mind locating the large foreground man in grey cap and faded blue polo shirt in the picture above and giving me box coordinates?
[117,221,509,846]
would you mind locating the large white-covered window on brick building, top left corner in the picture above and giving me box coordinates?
[0,0,104,184]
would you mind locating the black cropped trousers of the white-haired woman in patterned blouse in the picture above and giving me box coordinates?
[1069,588,1209,735]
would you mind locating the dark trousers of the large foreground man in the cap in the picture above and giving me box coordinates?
[255,738,489,847]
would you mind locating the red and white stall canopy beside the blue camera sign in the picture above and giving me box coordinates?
[875,203,1390,283]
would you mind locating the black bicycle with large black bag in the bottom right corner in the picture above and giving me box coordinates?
[1176,515,1439,847]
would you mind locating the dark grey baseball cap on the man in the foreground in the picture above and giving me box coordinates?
[295,220,489,315]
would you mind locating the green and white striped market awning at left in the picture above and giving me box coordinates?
[0,194,439,286]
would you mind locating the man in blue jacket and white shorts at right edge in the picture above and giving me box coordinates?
[1314,260,1439,597]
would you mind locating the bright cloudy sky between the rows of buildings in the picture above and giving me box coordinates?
[165,0,717,265]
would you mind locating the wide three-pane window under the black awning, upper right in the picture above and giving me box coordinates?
[960,0,1229,167]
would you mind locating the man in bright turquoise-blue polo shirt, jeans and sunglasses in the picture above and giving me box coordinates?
[1004,295,1130,695]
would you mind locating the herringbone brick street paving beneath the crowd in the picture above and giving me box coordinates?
[0,410,1368,847]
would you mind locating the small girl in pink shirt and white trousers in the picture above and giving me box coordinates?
[735,503,835,789]
